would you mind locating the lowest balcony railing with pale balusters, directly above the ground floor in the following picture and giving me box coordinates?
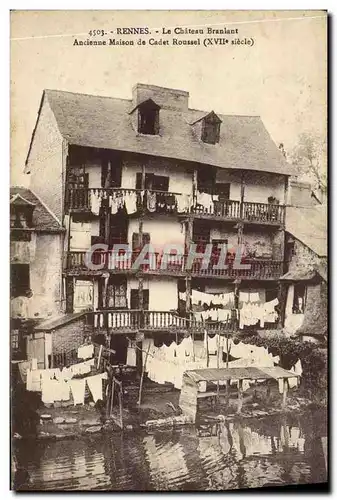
[87,309,237,333]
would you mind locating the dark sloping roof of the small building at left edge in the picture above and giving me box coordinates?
[10,186,63,232]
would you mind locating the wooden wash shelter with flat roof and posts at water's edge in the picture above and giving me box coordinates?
[179,366,300,422]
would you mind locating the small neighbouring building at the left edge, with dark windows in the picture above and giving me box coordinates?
[10,187,65,359]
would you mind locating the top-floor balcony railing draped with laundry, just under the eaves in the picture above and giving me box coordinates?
[66,188,284,224]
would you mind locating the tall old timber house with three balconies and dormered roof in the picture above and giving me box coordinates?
[12,84,308,368]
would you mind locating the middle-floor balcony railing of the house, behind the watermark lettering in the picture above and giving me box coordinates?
[66,251,283,280]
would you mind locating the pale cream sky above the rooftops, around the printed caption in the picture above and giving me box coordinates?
[11,10,327,185]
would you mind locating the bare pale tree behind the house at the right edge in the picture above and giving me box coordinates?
[290,132,327,193]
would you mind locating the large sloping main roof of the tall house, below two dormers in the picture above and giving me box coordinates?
[27,90,292,175]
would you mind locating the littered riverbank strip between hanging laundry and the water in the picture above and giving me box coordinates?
[11,379,324,440]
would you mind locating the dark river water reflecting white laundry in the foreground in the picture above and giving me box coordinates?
[13,412,327,491]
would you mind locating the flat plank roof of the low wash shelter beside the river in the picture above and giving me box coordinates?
[185,366,299,383]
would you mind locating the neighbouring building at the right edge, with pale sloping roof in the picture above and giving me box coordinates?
[281,205,328,344]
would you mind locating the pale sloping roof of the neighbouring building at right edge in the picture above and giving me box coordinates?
[285,205,328,257]
